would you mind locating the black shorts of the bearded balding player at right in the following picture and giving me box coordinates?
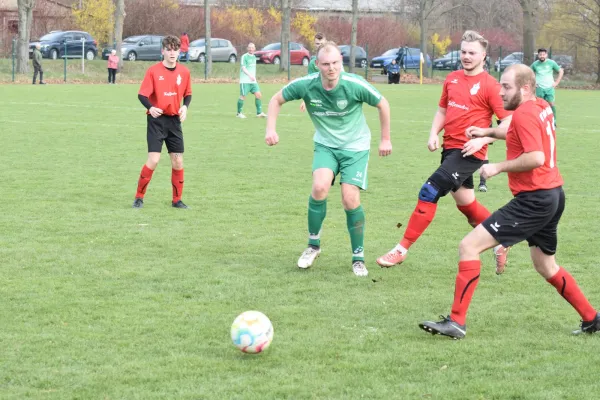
[482,186,565,256]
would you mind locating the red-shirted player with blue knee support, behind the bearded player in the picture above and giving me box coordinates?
[377,31,511,274]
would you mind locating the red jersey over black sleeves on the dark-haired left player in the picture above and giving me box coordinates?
[138,62,192,116]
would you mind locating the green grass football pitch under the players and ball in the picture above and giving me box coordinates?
[0,84,600,399]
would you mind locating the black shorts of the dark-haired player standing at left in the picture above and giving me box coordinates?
[147,114,183,153]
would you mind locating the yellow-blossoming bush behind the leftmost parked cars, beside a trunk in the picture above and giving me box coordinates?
[72,0,115,43]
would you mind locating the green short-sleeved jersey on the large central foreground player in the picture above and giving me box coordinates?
[283,72,382,151]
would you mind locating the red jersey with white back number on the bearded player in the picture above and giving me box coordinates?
[506,99,563,196]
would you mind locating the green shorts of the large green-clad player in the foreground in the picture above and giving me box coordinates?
[312,143,369,190]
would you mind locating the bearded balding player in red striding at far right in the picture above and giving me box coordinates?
[419,64,600,339]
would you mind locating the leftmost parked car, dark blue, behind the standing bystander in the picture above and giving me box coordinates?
[29,31,98,60]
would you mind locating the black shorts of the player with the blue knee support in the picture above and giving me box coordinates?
[428,149,484,197]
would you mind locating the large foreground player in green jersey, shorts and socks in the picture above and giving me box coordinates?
[265,42,392,276]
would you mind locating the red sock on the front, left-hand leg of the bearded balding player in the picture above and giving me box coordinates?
[450,260,482,325]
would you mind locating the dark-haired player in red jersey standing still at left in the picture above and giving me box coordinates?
[133,36,192,208]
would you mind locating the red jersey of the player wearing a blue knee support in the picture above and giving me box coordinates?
[439,70,511,160]
